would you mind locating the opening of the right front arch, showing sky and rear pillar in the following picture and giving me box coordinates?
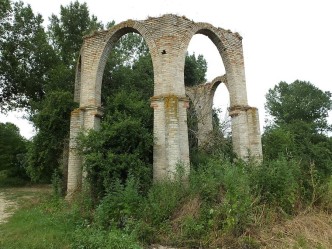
[185,32,227,158]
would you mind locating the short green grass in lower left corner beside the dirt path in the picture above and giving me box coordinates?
[0,186,75,249]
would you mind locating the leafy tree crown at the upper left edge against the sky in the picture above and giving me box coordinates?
[0,1,57,112]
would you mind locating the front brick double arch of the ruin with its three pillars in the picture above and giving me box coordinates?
[67,14,259,195]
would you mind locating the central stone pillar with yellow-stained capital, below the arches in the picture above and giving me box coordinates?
[151,94,189,181]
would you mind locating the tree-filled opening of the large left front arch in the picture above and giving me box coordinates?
[85,29,154,193]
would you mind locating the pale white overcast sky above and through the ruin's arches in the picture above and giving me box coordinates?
[0,0,332,137]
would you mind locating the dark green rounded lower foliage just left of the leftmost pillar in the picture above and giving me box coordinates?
[27,91,75,182]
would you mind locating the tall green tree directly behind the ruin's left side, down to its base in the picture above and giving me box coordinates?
[27,1,103,182]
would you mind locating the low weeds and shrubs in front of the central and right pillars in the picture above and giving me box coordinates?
[87,159,254,244]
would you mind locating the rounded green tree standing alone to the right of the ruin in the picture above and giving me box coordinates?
[262,81,332,179]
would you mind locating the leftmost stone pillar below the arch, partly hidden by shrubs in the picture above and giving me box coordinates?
[67,106,102,198]
